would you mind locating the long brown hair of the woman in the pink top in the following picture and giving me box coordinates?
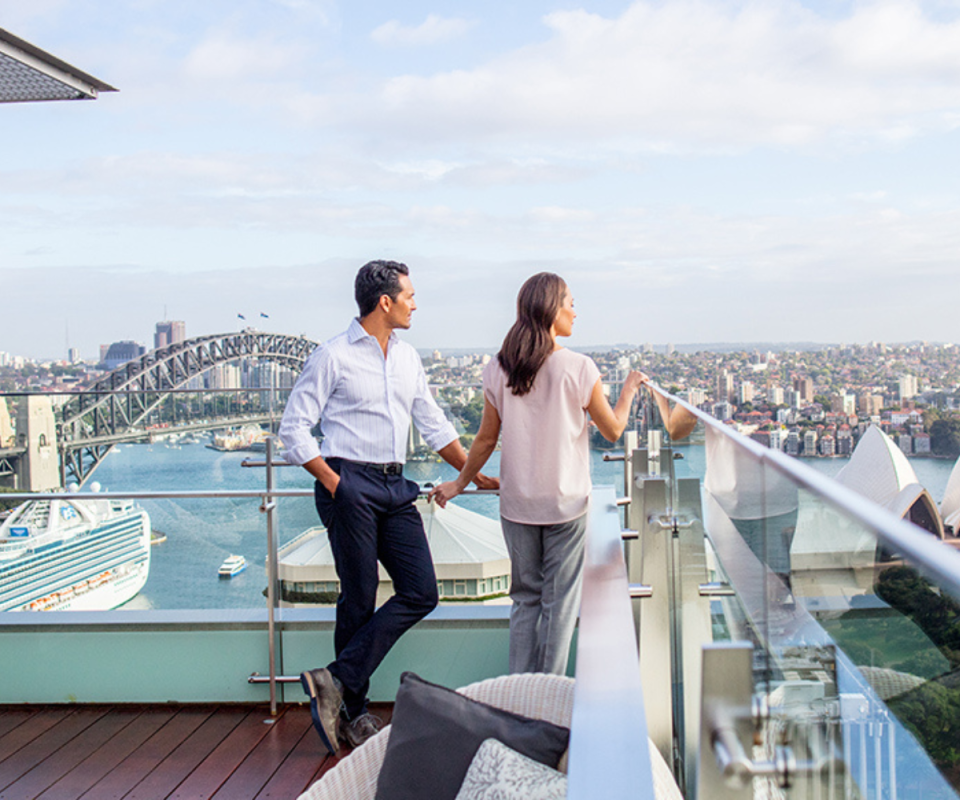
[497,272,567,396]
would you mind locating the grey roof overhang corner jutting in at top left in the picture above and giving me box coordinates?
[0,28,117,103]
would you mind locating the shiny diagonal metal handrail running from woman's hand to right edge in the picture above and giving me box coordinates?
[647,383,960,597]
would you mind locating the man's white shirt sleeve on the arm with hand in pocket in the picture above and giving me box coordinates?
[278,348,337,464]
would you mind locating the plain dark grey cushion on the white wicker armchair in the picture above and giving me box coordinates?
[376,672,570,800]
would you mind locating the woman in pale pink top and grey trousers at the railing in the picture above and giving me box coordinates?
[430,272,647,675]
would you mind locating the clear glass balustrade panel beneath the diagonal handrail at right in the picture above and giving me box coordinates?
[703,410,960,797]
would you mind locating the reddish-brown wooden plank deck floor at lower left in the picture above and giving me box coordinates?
[0,705,392,800]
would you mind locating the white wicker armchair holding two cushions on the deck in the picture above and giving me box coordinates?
[299,674,683,800]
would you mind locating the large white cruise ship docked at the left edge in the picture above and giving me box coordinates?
[0,495,150,611]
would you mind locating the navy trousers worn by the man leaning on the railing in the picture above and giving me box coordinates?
[314,458,439,718]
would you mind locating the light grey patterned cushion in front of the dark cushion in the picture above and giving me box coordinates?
[456,739,567,800]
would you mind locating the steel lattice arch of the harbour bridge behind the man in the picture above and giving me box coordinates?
[57,331,318,484]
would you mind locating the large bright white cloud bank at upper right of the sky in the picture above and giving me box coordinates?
[350,0,960,150]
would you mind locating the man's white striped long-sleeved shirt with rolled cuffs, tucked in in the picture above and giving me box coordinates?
[280,319,457,464]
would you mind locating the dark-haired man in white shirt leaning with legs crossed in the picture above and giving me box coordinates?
[280,261,499,753]
